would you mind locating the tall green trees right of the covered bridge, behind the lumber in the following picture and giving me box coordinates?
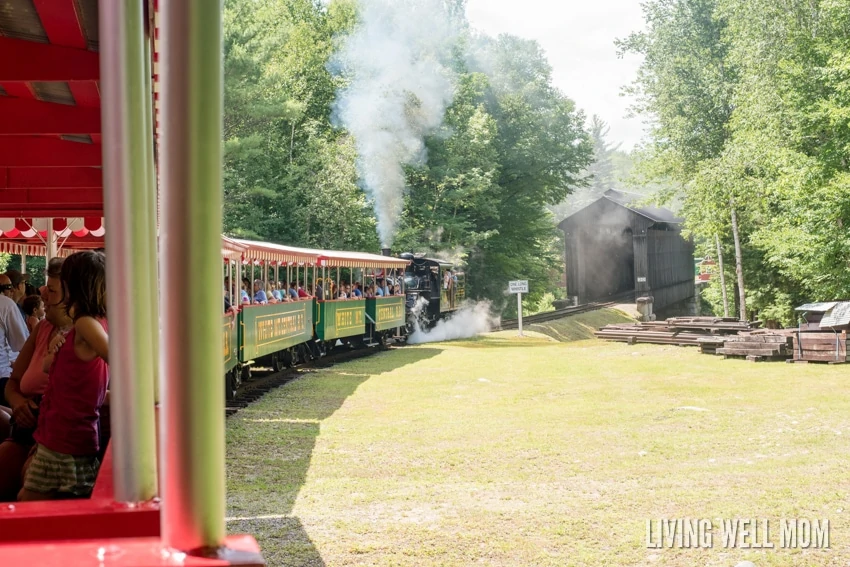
[620,0,850,324]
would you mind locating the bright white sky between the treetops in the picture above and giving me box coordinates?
[466,0,644,150]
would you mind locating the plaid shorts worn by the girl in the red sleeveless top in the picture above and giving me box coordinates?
[24,444,100,496]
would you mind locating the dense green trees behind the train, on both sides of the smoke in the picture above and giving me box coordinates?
[224,0,592,305]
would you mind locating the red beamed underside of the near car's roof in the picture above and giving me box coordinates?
[0,0,103,217]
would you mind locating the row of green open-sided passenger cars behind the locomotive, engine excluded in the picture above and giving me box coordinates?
[222,239,408,398]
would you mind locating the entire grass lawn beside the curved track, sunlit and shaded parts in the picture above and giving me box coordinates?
[227,331,850,567]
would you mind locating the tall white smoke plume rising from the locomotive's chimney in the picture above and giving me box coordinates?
[330,0,459,247]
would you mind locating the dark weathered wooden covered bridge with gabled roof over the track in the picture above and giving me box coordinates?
[558,190,694,309]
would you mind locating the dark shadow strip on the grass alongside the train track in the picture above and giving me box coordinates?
[227,348,442,567]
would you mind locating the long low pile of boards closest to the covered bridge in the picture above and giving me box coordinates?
[594,317,758,352]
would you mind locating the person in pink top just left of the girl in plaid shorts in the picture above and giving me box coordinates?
[0,258,73,502]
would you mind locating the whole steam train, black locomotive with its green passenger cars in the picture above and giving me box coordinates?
[222,237,466,399]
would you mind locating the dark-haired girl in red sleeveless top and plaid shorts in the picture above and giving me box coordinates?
[18,252,109,500]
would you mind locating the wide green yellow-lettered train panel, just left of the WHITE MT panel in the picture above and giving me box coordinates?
[239,299,314,363]
